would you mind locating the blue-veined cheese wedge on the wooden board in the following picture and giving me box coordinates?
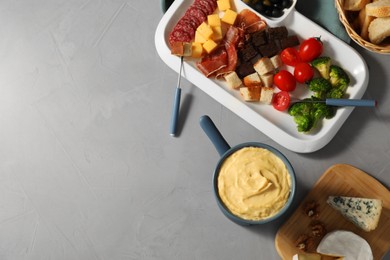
[327,196,382,231]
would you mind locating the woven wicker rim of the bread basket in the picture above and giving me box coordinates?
[335,0,390,54]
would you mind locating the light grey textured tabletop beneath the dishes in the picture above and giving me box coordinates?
[0,0,390,260]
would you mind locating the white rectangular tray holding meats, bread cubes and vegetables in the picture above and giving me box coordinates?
[155,0,369,153]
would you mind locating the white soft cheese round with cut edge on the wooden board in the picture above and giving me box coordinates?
[317,230,373,260]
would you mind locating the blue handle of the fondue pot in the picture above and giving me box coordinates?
[199,115,230,156]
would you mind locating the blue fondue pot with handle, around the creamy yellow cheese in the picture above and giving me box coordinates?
[199,115,296,226]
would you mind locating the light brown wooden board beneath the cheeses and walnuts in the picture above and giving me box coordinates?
[275,164,390,259]
